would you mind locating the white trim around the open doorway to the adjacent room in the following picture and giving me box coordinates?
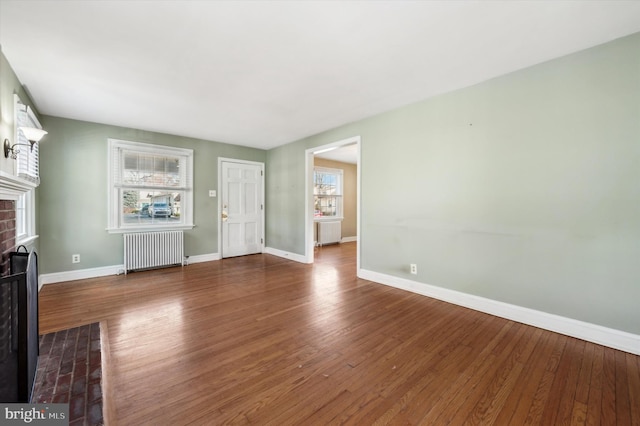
[304,135,362,274]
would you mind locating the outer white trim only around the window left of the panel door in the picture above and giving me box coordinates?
[106,138,195,234]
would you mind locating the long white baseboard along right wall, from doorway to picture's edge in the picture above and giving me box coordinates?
[358,269,640,355]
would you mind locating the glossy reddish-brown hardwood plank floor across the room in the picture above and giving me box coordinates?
[40,243,640,425]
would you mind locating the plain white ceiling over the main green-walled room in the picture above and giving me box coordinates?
[0,0,640,149]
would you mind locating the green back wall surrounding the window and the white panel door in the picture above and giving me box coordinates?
[37,116,266,274]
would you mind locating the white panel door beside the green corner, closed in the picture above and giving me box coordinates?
[221,161,263,258]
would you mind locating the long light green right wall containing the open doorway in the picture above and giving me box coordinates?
[266,34,640,334]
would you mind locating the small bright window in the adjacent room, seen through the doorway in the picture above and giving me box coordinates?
[313,167,343,220]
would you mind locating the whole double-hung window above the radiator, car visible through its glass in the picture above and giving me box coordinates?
[108,139,193,232]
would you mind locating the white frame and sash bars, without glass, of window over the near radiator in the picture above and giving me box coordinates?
[107,138,195,233]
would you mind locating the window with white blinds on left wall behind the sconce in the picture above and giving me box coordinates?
[14,95,42,185]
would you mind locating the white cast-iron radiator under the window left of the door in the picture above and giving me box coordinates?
[124,231,184,274]
